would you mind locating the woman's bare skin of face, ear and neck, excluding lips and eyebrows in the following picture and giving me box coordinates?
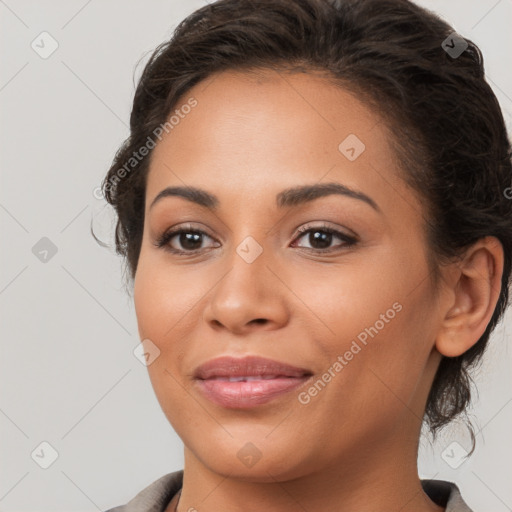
[134,71,503,512]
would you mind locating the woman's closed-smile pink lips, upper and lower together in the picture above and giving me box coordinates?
[194,356,312,409]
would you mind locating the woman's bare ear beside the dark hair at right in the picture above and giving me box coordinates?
[436,237,504,357]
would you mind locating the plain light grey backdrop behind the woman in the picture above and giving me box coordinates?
[0,0,512,512]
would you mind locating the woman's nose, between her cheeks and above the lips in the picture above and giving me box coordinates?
[203,242,289,334]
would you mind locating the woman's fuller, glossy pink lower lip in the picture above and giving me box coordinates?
[197,376,310,409]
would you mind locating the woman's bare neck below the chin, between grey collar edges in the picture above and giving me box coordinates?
[175,425,444,512]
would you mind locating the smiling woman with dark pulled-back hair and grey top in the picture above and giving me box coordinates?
[103,0,512,512]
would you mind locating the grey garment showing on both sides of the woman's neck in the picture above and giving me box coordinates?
[105,470,472,512]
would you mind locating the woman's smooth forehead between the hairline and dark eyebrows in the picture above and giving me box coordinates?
[147,66,412,214]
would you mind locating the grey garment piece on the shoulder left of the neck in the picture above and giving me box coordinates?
[105,470,183,512]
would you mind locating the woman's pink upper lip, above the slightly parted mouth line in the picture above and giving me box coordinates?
[194,356,312,380]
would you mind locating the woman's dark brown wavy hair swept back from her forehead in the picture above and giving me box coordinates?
[102,0,512,452]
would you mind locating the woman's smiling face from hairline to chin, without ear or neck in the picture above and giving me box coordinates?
[134,71,446,481]
